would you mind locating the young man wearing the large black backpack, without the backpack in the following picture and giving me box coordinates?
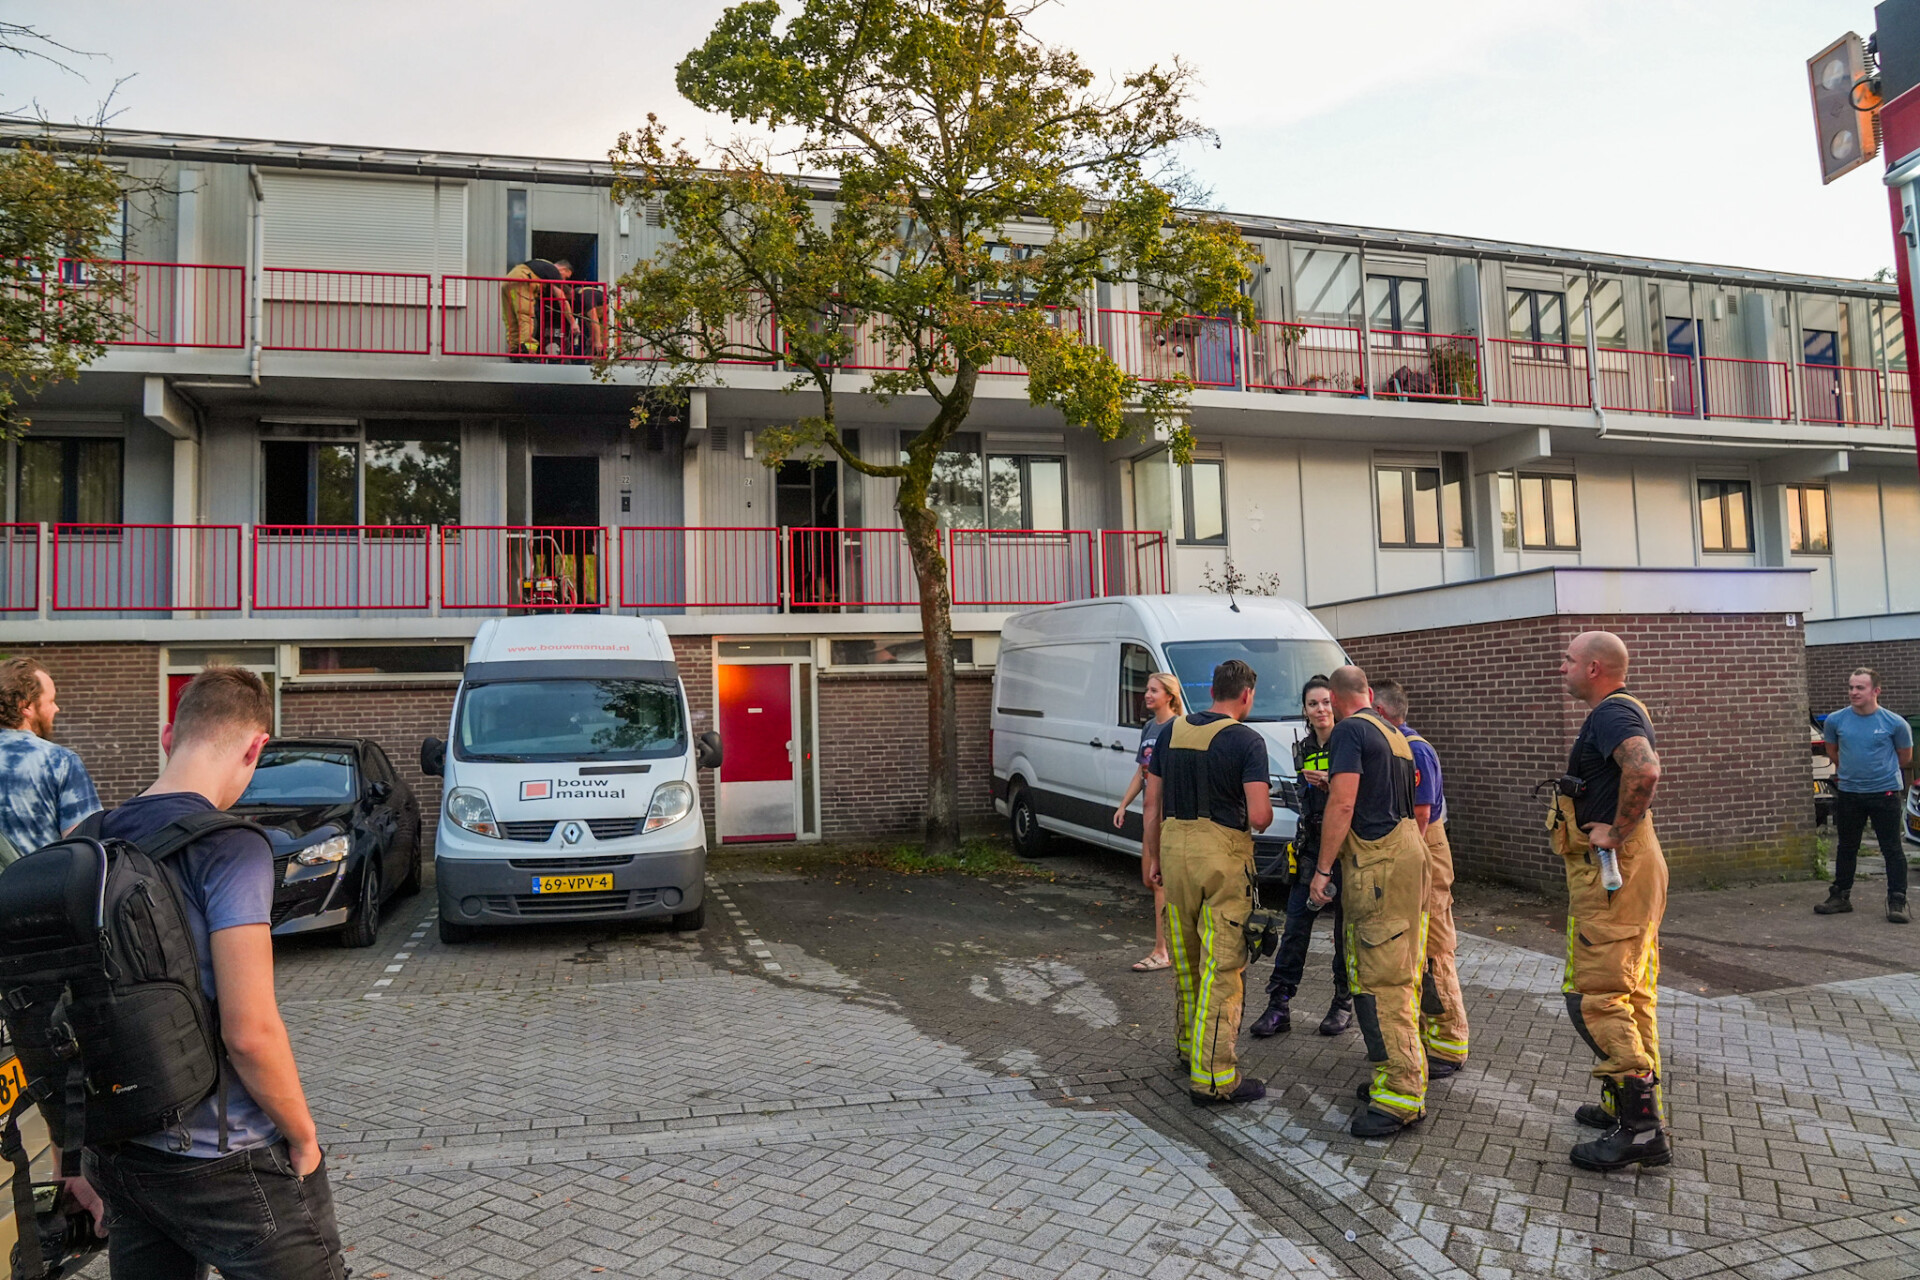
[69,668,346,1280]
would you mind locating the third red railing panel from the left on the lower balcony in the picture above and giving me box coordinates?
[252,524,432,610]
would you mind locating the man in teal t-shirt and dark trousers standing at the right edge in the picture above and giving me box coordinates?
[1814,666,1914,925]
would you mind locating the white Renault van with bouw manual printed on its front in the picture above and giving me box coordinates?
[420,614,720,942]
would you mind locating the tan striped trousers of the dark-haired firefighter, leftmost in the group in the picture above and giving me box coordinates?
[1160,818,1254,1096]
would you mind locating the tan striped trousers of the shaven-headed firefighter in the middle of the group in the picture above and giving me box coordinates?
[1340,818,1427,1121]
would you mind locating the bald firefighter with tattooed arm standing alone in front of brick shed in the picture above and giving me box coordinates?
[1548,631,1672,1171]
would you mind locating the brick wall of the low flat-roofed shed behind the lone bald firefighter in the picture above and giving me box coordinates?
[1342,614,1812,889]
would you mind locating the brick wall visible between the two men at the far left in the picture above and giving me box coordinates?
[0,645,165,806]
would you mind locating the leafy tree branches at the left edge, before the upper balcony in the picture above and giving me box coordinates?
[0,23,132,439]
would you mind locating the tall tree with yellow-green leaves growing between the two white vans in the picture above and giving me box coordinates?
[612,0,1256,852]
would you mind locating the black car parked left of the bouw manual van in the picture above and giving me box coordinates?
[232,737,420,946]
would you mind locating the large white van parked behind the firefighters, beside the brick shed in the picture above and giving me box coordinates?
[993,595,1346,873]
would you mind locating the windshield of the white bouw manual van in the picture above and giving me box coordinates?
[453,679,685,762]
